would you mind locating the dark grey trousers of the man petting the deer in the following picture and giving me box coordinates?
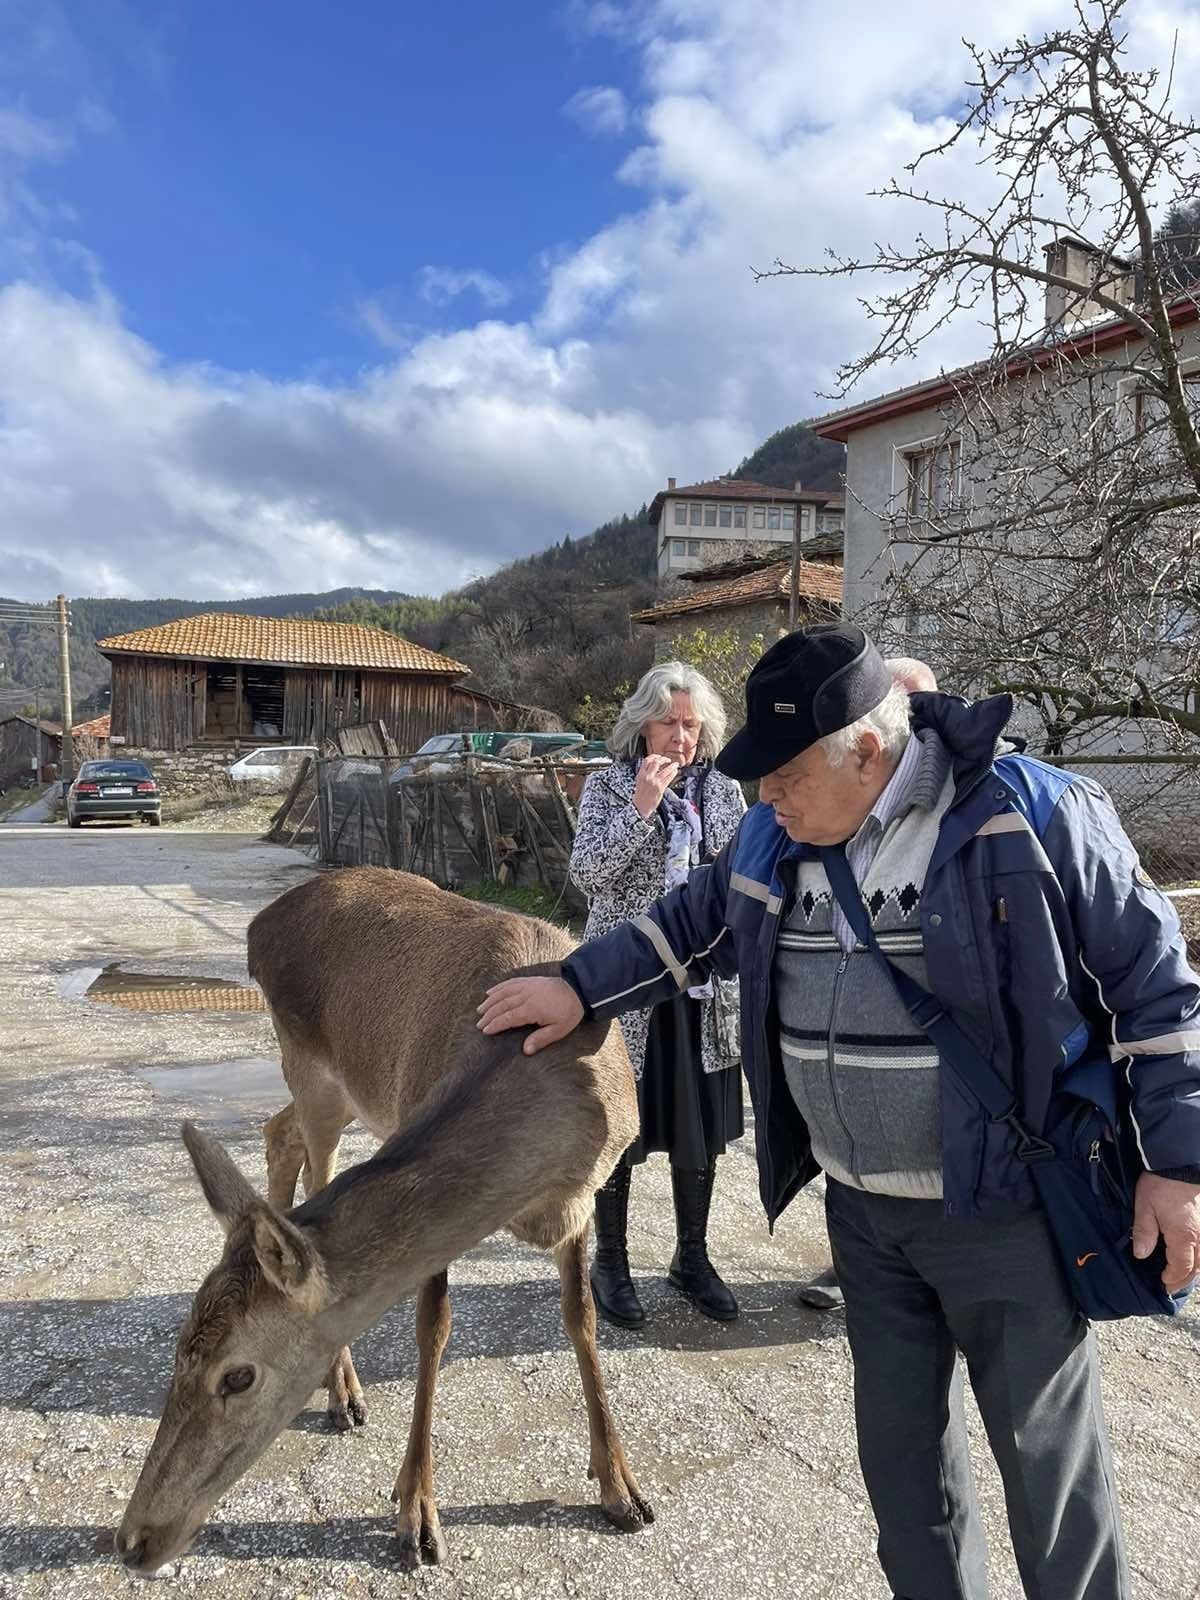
[826,1179,1131,1600]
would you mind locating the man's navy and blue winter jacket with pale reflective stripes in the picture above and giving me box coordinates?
[565,694,1200,1226]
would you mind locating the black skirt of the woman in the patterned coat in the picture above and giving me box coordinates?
[622,995,744,1171]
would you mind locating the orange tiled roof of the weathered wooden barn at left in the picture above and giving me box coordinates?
[96,611,470,677]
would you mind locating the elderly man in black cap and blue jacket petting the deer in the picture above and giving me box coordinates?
[480,624,1200,1600]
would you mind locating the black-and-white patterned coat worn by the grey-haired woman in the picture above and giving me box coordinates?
[571,762,746,1078]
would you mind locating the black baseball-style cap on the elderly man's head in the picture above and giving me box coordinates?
[717,622,891,778]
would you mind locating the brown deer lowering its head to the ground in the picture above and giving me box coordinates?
[115,867,654,1576]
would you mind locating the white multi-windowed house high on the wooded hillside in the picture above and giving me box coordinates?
[650,478,845,581]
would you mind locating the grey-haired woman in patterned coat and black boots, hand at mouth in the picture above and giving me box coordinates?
[571,661,746,1328]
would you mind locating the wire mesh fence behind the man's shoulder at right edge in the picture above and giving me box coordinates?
[1056,755,1200,888]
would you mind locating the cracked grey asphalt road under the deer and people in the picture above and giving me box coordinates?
[0,827,1200,1600]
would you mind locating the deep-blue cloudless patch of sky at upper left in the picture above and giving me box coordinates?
[30,0,640,378]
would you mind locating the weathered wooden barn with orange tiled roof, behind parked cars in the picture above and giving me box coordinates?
[96,611,469,750]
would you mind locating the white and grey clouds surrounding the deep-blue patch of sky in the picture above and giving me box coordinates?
[0,0,1200,597]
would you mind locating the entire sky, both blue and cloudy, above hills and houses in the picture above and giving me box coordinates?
[0,0,1200,600]
